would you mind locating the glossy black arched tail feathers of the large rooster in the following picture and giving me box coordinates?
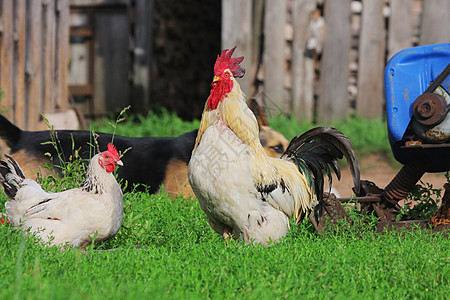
[283,127,360,201]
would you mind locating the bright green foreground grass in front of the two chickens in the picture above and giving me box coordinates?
[0,192,450,299]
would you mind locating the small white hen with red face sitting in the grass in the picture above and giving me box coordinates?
[0,144,123,248]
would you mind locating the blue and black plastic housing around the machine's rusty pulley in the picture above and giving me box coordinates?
[385,43,450,172]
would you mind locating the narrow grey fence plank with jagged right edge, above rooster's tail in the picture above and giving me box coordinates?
[291,0,317,122]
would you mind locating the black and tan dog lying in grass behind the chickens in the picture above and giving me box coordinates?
[0,102,288,197]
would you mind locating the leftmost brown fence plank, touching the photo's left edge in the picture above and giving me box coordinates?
[0,0,14,121]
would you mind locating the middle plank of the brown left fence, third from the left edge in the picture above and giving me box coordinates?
[25,0,43,129]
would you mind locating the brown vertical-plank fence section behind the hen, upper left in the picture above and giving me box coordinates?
[0,0,69,129]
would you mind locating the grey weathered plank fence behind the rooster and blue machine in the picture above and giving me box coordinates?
[222,0,450,122]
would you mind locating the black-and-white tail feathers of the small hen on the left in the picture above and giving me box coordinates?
[0,154,25,199]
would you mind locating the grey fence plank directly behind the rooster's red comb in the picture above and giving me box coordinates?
[222,0,255,96]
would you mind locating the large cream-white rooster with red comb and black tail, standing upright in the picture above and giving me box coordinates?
[188,48,359,244]
